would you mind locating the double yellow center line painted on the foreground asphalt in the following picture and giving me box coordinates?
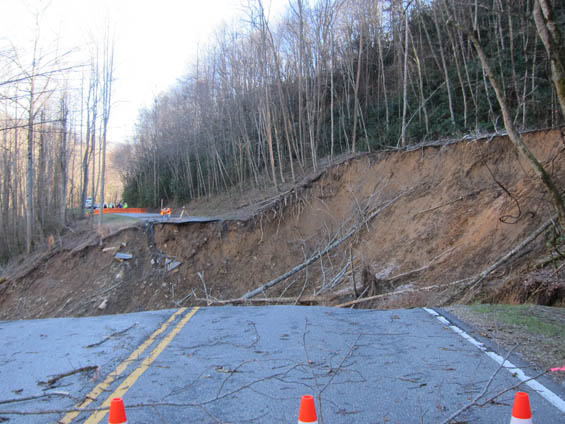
[60,307,199,424]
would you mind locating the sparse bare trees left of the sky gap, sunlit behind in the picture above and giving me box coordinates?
[0,11,121,265]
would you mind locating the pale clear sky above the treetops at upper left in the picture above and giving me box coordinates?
[0,0,288,142]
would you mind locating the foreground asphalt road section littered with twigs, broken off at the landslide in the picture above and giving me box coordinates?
[0,306,565,424]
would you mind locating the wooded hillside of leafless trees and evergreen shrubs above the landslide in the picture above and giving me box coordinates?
[124,0,565,207]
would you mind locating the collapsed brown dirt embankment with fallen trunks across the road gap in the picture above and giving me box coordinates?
[0,130,565,319]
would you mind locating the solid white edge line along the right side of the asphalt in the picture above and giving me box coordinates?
[422,308,565,413]
